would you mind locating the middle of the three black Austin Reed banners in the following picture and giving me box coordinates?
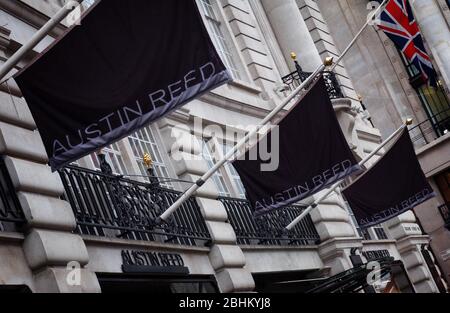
[233,78,359,216]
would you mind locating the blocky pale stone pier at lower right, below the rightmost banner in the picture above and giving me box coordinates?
[385,211,439,293]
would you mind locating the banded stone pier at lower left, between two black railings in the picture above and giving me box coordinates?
[0,92,100,293]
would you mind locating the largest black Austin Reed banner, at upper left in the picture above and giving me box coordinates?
[15,0,230,170]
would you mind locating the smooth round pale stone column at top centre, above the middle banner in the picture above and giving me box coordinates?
[261,0,322,72]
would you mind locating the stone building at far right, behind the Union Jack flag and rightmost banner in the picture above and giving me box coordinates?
[314,0,450,288]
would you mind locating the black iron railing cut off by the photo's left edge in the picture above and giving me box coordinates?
[0,157,25,231]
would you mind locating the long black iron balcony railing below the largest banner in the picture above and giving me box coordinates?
[59,166,210,246]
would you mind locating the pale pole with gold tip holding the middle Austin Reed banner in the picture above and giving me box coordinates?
[157,59,326,223]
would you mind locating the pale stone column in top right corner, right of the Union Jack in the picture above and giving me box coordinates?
[410,0,450,90]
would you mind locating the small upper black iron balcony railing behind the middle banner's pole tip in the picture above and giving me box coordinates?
[282,69,344,99]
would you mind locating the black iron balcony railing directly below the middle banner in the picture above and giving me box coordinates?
[219,198,320,246]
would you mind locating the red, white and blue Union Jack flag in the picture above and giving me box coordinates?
[375,0,436,86]
